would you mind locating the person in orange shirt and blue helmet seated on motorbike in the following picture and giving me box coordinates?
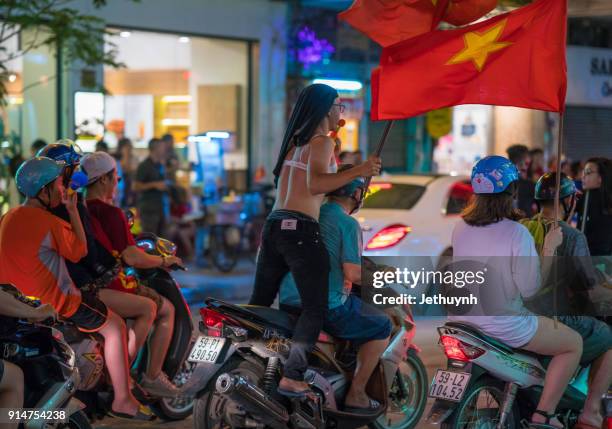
[0,157,154,420]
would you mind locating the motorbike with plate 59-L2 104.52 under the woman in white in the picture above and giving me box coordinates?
[428,322,612,429]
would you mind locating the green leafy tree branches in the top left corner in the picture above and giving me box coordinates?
[0,0,139,104]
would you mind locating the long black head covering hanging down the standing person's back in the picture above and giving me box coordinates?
[273,83,338,184]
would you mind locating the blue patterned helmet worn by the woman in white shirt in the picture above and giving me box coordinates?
[472,155,519,194]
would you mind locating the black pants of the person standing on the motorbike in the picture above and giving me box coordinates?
[249,210,329,381]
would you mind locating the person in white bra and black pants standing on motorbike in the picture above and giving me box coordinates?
[249,84,381,396]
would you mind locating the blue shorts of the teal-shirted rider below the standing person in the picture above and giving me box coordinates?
[323,295,391,344]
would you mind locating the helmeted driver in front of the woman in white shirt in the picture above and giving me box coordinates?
[521,173,612,429]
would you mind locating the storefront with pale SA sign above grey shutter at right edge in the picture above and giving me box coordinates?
[564,46,612,161]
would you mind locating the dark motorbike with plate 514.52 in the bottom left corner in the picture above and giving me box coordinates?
[0,285,91,429]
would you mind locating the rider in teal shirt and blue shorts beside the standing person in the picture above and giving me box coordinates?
[280,165,391,414]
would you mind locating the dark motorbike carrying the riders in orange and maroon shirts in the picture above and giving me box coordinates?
[59,233,201,420]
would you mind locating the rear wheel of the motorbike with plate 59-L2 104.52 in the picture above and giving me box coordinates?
[442,377,521,429]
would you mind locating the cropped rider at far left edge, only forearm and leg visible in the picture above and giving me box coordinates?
[0,288,57,429]
